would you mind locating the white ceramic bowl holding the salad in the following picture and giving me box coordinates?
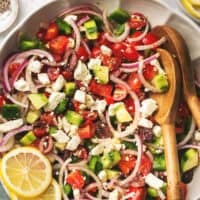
[0,0,200,200]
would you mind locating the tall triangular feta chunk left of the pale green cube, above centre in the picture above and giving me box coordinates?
[74,60,92,84]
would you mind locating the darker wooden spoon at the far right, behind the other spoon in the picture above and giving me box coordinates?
[153,26,200,128]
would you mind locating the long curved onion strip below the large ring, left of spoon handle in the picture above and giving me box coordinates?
[119,134,143,187]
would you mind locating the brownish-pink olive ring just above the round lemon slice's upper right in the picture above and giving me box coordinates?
[39,136,53,154]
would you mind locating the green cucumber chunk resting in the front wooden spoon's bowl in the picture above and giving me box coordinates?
[152,74,169,92]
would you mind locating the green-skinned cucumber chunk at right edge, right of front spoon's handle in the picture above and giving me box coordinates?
[181,149,199,173]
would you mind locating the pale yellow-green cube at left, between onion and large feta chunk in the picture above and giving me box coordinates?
[28,93,48,110]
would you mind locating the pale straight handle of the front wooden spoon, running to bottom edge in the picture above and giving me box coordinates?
[162,123,182,200]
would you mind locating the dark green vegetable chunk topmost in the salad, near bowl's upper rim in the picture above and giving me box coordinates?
[108,8,130,24]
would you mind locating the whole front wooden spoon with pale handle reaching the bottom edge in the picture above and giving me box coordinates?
[151,49,182,200]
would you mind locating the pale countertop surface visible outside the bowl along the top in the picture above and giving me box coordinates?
[0,0,197,46]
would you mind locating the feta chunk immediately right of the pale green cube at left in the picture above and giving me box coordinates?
[44,92,65,112]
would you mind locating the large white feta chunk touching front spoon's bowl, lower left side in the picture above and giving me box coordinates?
[140,98,158,118]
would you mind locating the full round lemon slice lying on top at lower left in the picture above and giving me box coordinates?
[1,147,52,199]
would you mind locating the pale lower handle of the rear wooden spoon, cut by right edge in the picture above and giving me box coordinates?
[185,96,200,129]
